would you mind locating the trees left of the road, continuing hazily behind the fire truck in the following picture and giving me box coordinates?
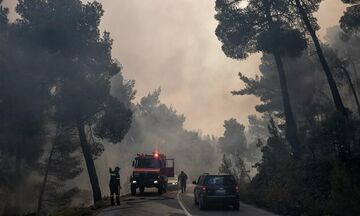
[0,0,218,216]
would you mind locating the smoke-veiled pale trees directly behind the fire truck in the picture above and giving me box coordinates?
[89,89,221,195]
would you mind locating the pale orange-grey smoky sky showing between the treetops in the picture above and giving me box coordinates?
[5,0,345,136]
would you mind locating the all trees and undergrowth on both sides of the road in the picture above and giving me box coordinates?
[0,0,360,216]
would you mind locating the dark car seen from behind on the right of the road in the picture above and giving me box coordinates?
[193,174,240,210]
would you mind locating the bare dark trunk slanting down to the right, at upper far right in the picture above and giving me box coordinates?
[295,0,347,115]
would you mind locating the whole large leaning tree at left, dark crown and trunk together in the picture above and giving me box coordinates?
[12,0,133,202]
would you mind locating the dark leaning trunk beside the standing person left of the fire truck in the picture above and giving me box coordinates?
[77,121,101,203]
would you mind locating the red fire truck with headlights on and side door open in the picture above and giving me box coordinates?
[130,152,175,196]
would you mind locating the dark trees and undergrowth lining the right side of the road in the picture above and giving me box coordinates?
[215,0,360,216]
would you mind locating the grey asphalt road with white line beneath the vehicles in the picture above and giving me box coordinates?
[97,185,275,216]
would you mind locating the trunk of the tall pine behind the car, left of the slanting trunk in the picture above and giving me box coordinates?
[263,0,301,159]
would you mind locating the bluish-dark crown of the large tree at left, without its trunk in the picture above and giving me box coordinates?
[16,0,132,133]
